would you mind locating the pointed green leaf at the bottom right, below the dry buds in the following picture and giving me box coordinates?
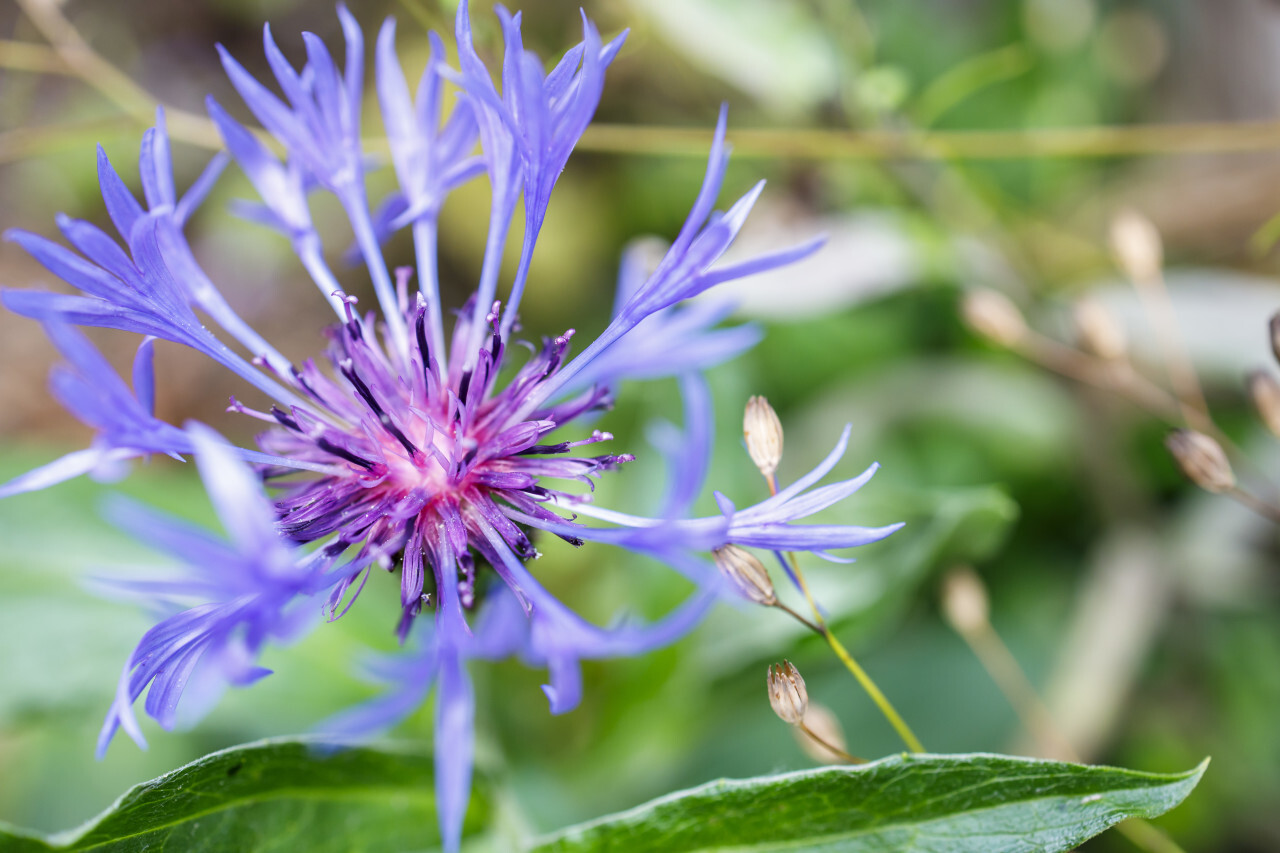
[524,754,1207,853]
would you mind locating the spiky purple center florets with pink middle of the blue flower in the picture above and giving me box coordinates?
[232,281,624,638]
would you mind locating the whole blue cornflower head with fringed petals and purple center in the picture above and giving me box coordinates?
[0,3,896,849]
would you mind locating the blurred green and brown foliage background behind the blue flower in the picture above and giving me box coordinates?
[0,0,1280,853]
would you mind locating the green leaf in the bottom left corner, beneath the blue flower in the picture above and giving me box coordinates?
[0,739,492,853]
